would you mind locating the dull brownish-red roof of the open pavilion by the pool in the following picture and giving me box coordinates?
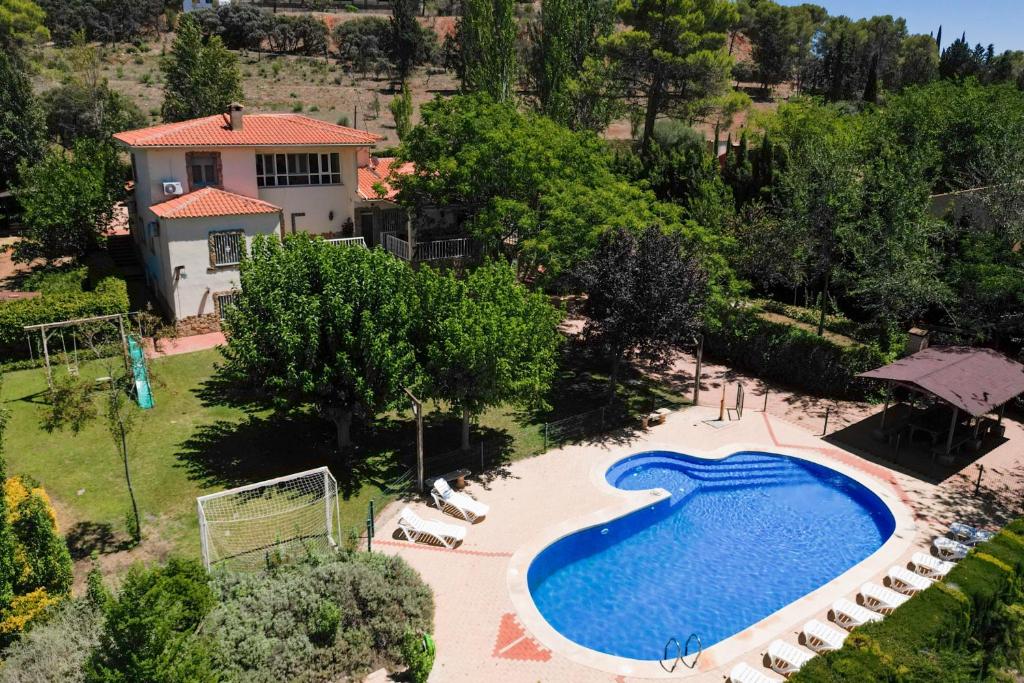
[858,346,1024,417]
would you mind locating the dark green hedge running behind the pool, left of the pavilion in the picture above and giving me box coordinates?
[705,307,893,398]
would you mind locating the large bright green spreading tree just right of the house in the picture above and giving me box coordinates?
[398,95,707,278]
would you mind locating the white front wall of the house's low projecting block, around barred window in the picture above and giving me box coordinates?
[161,214,281,319]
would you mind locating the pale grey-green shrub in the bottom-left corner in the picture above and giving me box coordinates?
[0,600,103,683]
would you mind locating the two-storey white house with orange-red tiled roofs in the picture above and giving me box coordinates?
[114,104,404,327]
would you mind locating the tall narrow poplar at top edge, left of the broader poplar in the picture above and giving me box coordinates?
[456,0,519,102]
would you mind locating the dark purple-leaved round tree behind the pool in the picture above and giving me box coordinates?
[573,226,710,400]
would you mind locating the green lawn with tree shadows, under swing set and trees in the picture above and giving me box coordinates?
[2,350,680,569]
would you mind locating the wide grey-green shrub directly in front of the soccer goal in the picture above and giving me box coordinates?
[204,553,433,681]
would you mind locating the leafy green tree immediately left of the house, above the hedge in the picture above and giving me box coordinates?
[13,139,126,262]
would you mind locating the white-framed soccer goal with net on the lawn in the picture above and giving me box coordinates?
[196,467,340,570]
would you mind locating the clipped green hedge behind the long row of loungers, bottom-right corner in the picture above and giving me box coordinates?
[790,521,1024,683]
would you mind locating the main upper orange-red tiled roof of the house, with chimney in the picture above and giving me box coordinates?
[114,114,383,147]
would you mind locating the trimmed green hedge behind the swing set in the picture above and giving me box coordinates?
[0,275,128,355]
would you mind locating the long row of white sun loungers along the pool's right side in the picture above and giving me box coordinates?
[729,522,994,683]
